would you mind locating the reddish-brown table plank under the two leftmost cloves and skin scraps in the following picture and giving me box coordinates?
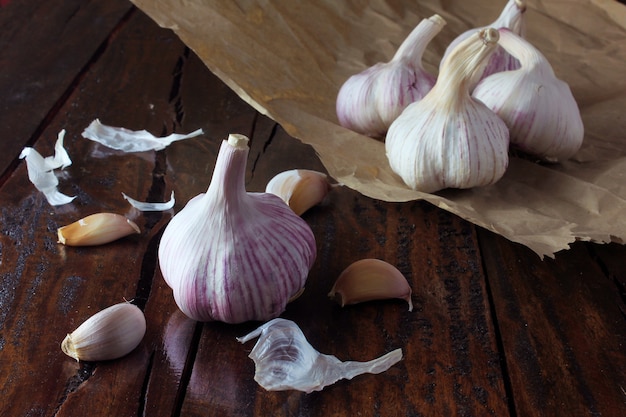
[0,9,187,416]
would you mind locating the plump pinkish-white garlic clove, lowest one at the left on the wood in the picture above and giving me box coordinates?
[61,303,146,361]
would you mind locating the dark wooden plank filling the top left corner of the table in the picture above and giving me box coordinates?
[0,0,133,183]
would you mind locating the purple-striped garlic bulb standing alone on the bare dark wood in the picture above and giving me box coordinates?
[158,135,316,323]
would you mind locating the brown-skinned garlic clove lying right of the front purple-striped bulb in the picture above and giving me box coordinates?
[328,259,413,311]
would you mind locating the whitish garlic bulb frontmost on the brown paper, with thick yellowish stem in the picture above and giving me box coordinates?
[385,28,509,193]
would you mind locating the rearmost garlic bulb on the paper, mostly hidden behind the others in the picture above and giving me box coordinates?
[440,0,526,79]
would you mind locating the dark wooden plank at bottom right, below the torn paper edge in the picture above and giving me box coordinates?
[480,231,626,416]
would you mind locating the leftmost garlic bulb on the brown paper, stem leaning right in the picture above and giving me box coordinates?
[336,15,446,137]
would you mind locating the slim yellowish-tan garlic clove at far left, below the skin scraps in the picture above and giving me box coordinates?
[57,213,141,246]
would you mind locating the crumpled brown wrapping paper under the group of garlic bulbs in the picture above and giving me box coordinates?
[133,0,626,257]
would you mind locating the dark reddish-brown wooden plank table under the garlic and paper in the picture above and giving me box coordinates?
[0,0,626,417]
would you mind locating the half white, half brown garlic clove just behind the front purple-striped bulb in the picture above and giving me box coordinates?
[265,169,332,216]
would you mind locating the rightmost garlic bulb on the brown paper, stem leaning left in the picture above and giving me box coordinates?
[473,29,585,161]
